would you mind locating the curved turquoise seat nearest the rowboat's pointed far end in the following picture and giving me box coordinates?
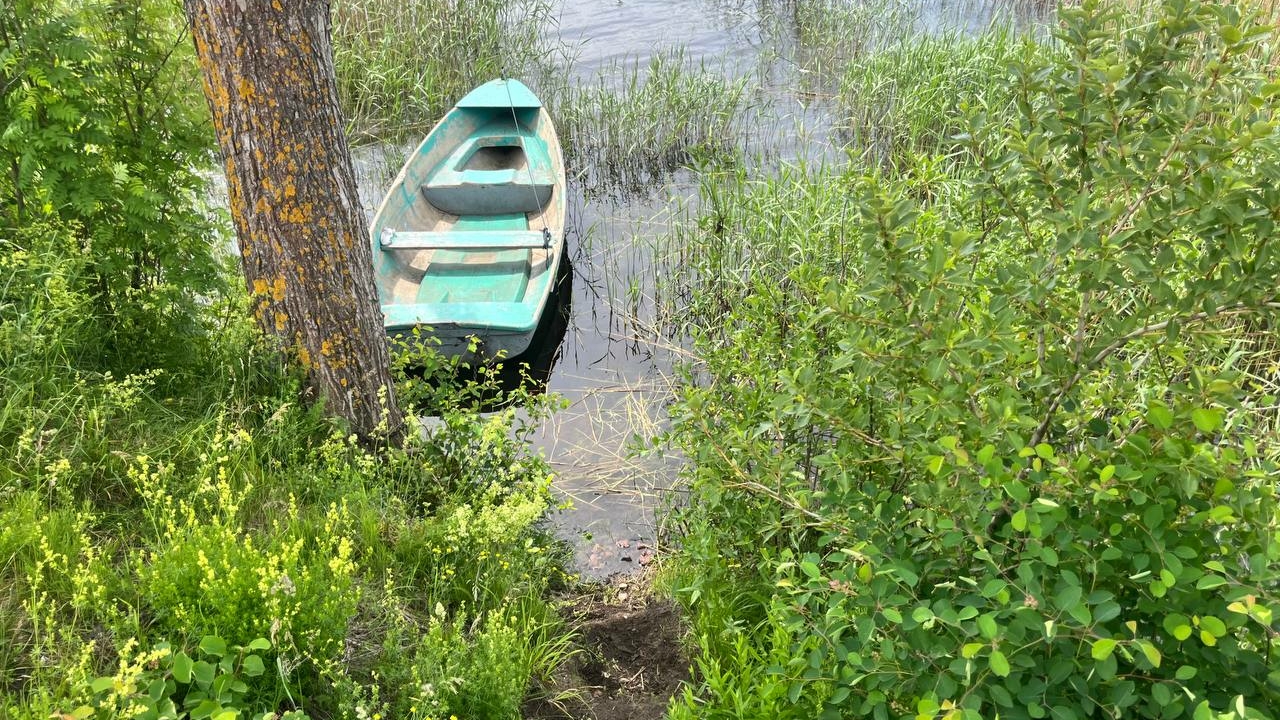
[422,120,556,215]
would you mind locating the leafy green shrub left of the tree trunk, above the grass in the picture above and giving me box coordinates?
[0,0,223,372]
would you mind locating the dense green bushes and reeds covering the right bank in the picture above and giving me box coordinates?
[673,0,1280,720]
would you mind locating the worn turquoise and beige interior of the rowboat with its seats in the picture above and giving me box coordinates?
[372,96,564,327]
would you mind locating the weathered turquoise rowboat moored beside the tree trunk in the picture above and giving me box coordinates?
[371,79,564,360]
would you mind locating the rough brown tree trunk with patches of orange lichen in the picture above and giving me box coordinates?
[184,0,403,439]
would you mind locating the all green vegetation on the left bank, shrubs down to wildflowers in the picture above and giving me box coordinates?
[0,0,567,720]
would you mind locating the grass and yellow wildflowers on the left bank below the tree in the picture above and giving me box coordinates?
[0,227,570,719]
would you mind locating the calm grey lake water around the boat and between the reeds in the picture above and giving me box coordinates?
[356,0,1054,577]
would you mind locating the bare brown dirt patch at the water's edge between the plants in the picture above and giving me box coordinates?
[525,577,689,720]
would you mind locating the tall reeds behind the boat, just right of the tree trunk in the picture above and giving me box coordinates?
[333,0,563,143]
